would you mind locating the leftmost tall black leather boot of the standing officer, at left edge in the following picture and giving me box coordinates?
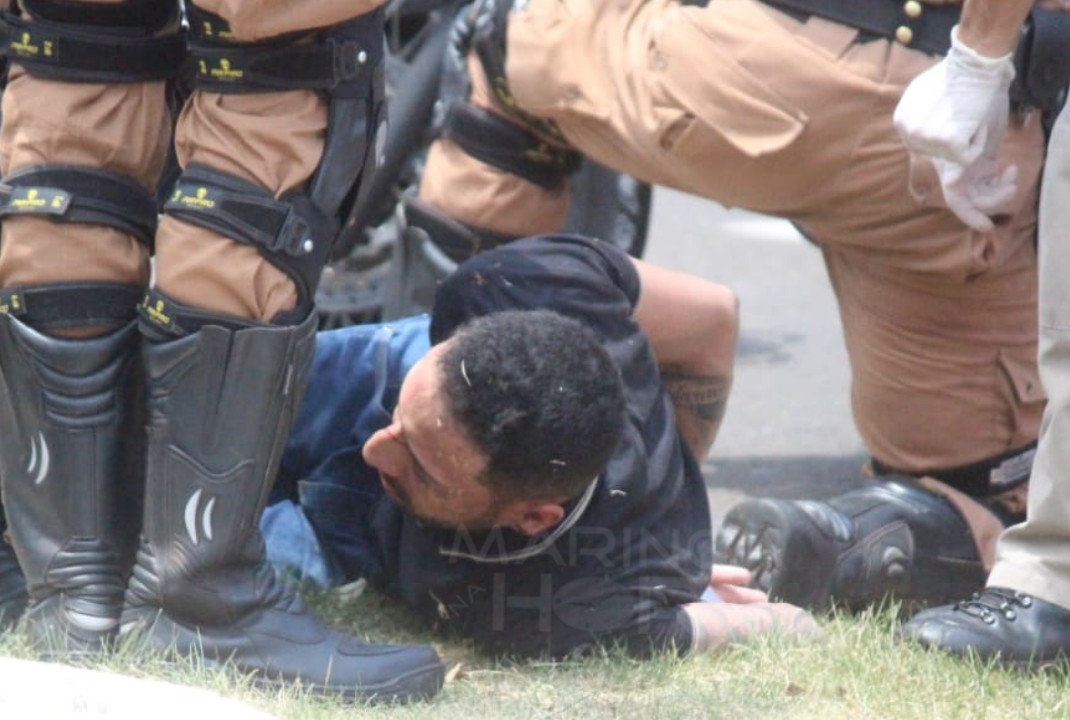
[0,315,143,654]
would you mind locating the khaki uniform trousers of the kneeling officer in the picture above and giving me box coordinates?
[421,0,1044,474]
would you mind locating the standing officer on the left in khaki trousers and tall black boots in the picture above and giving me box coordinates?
[0,0,443,699]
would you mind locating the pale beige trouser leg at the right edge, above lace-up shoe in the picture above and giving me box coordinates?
[989,99,1070,609]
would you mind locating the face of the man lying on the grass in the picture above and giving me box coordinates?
[364,344,502,530]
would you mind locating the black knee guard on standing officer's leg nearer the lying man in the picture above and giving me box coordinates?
[164,6,386,324]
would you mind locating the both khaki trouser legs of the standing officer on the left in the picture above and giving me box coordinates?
[0,0,385,320]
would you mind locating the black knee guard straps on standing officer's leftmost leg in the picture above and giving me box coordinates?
[0,0,185,331]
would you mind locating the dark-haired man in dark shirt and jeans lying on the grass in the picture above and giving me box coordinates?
[264,236,820,658]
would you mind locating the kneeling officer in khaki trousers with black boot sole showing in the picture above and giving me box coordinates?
[408,0,1044,607]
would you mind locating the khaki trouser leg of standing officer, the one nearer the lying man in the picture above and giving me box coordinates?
[150,0,381,321]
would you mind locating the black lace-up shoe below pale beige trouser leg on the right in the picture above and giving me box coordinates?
[898,587,1070,668]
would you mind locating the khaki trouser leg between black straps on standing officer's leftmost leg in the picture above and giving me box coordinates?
[0,40,170,295]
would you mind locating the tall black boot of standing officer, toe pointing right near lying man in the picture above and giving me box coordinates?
[123,316,444,701]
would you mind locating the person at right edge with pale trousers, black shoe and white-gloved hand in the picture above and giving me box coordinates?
[896,0,1070,665]
